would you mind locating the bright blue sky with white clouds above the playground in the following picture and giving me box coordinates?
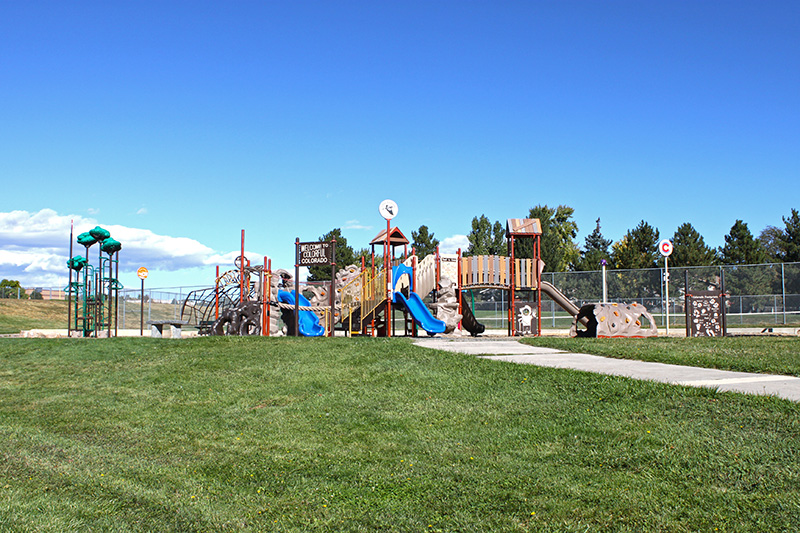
[0,0,800,287]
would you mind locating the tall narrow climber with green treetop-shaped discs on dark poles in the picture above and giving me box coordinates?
[64,226,123,337]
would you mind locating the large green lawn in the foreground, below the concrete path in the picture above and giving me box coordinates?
[0,338,800,532]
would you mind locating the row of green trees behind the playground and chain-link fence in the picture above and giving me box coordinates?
[309,205,800,281]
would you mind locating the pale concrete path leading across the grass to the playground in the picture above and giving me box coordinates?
[415,338,800,402]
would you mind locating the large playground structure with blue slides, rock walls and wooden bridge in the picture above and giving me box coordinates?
[181,215,657,337]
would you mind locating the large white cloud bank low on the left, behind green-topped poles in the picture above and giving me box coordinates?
[0,209,220,287]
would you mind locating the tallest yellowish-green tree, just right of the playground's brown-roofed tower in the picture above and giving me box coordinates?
[515,205,580,272]
